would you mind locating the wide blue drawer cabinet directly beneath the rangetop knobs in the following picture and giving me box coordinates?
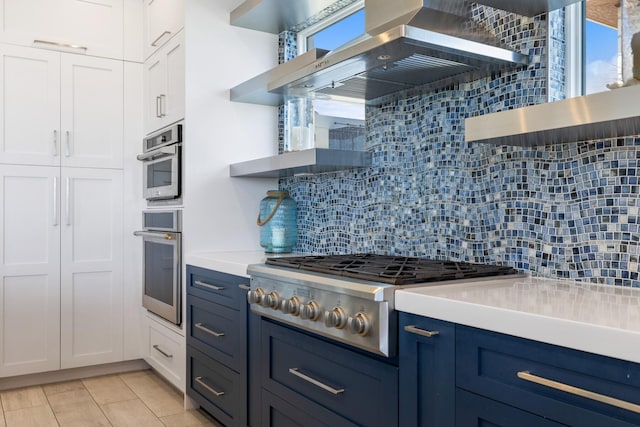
[260,319,398,427]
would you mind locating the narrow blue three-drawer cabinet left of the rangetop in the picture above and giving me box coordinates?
[186,265,249,427]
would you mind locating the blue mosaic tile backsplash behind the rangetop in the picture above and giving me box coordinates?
[280,7,640,287]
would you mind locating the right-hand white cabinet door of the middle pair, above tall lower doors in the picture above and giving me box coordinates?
[60,54,124,168]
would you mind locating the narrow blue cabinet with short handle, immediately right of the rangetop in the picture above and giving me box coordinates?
[399,313,456,427]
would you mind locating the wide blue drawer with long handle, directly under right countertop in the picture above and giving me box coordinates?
[456,326,640,427]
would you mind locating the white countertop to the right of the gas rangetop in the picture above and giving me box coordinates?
[395,277,640,363]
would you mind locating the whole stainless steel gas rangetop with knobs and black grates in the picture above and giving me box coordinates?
[247,254,518,356]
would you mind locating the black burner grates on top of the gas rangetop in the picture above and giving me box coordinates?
[266,254,518,286]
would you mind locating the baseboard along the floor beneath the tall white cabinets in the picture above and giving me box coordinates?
[0,359,151,390]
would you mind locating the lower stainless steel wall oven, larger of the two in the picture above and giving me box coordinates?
[134,210,182,325]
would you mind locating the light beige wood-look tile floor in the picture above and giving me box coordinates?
[0,370,219,427]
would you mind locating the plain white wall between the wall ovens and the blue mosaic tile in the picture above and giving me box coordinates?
[183,0,278,254]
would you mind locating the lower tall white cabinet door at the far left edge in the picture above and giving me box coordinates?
[0,165,60,377]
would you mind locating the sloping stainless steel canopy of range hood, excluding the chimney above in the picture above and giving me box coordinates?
[267,25,528,101]
